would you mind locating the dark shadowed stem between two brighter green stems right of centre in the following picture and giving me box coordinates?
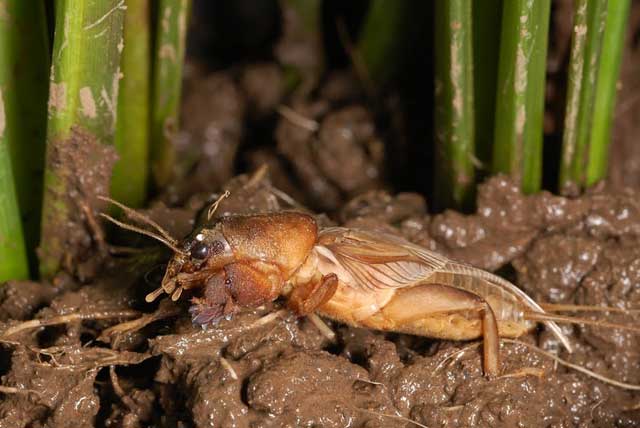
[473,0,503,172]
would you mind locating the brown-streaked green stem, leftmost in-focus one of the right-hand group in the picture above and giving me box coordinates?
[435,0,474,207]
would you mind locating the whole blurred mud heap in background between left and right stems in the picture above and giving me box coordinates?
[172,60,390,212]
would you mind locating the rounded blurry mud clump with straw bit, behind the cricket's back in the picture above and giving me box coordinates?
[276,102,384,211]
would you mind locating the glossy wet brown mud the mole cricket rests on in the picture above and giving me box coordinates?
[0,171,640,428]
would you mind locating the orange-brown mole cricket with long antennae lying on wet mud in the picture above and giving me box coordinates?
[101,192,640,385]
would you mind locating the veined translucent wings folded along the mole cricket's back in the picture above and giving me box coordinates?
[315,227,571,351]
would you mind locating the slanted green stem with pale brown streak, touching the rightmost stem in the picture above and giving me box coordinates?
[559,0,607,190]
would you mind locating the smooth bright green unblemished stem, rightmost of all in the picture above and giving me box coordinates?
[586,0,631,186]
